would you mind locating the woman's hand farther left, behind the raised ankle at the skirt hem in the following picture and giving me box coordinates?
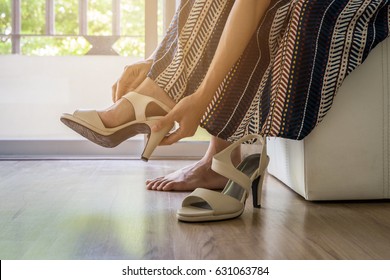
[112,60,153,103]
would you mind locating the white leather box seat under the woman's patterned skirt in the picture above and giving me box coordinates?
[268,40,390,200]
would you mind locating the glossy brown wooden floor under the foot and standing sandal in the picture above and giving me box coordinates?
[0,160,390,260]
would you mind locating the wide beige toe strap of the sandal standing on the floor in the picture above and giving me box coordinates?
[182,188,243,215]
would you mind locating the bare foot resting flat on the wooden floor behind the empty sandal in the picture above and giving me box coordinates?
[146,137,241,191]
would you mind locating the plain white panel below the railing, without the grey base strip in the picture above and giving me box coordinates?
[0,55,134,140]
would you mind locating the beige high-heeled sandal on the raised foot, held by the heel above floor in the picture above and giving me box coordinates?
[61,92,173,161]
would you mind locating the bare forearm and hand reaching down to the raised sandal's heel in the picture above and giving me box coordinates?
[153,0,270,145]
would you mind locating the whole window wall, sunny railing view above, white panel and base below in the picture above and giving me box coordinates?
[0,0,208,158]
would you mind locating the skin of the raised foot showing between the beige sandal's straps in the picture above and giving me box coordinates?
[98,78,175,127]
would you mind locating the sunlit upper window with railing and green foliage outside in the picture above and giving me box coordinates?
[0,0,175,57]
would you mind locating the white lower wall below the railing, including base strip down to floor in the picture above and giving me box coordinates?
[0,55,207,159]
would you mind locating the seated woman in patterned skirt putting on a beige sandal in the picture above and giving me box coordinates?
[62,0,389,219]
